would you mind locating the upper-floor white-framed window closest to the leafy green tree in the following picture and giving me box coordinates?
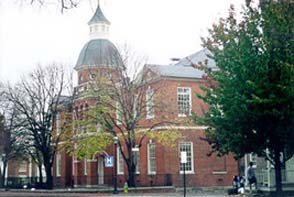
[178,87,192,117]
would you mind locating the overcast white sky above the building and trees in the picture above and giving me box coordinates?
[0,0,244,81]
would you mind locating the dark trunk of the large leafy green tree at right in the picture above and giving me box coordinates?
[274,148,283,197]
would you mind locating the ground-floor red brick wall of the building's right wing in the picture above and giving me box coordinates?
[130,130,238,186]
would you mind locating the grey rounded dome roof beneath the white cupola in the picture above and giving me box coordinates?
[75,39,123,70]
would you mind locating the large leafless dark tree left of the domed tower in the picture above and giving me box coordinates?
[5,64,65,189]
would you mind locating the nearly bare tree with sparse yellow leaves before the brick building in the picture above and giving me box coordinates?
[69,49,182,186]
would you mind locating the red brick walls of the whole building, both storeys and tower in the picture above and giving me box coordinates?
[51,67,238,187]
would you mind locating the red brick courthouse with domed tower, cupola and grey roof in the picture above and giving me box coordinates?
[53,3,238,188]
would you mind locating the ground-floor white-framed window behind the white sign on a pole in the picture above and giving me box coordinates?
[179,142,194,173]
